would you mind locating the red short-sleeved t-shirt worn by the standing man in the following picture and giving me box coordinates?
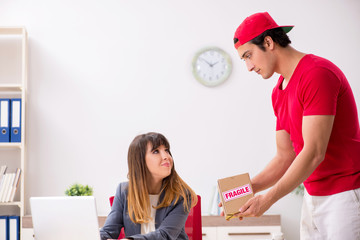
[272,54,360,196]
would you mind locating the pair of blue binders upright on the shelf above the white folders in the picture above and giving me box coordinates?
[0,98,21,142]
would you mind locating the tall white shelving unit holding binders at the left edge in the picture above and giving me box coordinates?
[0,27,28,238]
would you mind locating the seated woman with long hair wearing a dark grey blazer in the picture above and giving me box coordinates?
[100,132,197,240]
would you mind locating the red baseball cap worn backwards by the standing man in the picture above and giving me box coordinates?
[234,12,294,49]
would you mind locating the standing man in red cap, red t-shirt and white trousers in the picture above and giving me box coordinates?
[228,12,360,240]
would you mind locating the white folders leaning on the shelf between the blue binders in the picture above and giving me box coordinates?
[0,165,21,203]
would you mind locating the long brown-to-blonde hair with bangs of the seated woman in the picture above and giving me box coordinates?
[128,132,197,224]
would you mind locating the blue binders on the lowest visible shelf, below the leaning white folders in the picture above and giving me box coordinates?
[0,216,20,240]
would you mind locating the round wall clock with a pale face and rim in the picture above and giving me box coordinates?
[192,47,232,87]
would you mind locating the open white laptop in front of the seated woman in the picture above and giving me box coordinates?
[30,196,100,240]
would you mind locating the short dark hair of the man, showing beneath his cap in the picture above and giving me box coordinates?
[250,27,291,51]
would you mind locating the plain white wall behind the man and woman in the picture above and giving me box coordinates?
[0,0,360,239]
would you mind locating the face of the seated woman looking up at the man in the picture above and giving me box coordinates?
[145,143,173,180]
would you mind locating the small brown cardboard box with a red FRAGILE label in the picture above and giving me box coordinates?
[218,173,254,220]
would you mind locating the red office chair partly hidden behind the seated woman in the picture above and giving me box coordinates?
[109,195,202,240]
